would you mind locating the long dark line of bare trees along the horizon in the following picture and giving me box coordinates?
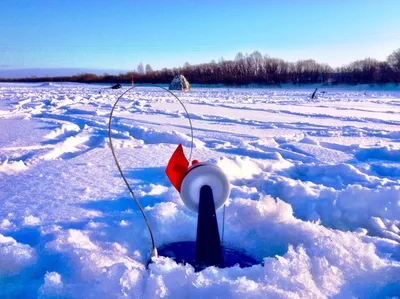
[1,49,400,86]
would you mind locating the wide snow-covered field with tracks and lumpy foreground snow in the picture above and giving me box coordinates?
[0,83,400,298]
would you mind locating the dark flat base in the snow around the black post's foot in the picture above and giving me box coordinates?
[158,242,260,271]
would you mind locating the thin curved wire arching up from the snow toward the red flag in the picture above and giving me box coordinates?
[108,85,194,257]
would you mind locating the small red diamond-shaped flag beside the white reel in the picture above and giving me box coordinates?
[165,144,189,192]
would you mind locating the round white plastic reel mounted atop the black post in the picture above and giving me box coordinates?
[181,162,231,213]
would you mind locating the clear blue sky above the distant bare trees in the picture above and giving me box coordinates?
[0,0,400,70]
